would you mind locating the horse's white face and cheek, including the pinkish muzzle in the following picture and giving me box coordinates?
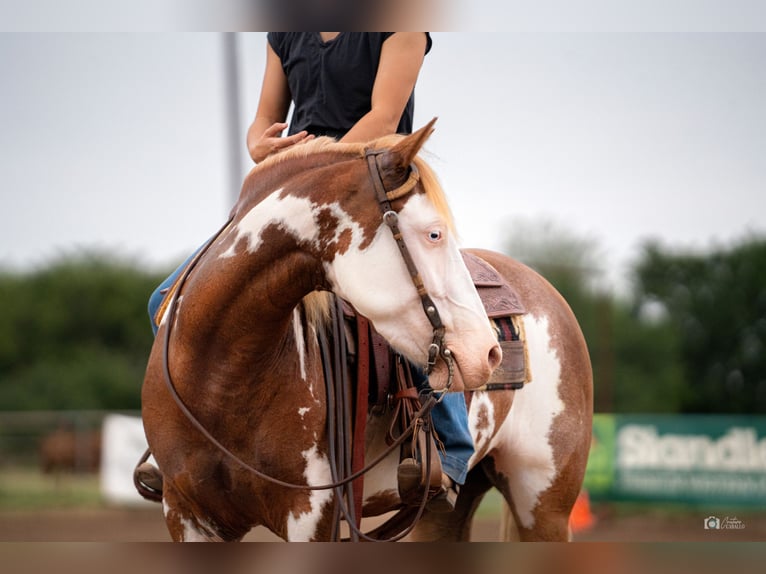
[348,194,497,388]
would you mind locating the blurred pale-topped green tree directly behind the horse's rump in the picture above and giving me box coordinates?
[505,220,683,412]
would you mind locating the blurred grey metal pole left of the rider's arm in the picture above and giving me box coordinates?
[223,32,243,209]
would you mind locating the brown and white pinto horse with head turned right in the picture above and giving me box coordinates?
[142,121,592,541]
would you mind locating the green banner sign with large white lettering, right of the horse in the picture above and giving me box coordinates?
[585,415,766,506]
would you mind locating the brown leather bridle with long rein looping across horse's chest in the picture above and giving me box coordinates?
[158,150,454,541]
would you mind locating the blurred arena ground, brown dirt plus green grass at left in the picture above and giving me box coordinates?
[0,470,766,543]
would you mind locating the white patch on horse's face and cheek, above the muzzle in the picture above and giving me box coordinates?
[325,194,496,372]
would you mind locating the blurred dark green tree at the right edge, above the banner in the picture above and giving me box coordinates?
[635,237,766,413]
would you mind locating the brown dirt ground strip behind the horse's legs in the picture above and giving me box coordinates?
[0,506,766,542]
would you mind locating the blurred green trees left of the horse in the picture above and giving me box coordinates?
[0,254,170,410]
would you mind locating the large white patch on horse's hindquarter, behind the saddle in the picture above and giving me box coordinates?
[493,315,564,528]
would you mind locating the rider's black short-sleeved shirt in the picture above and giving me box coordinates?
[268,32,431,138]
